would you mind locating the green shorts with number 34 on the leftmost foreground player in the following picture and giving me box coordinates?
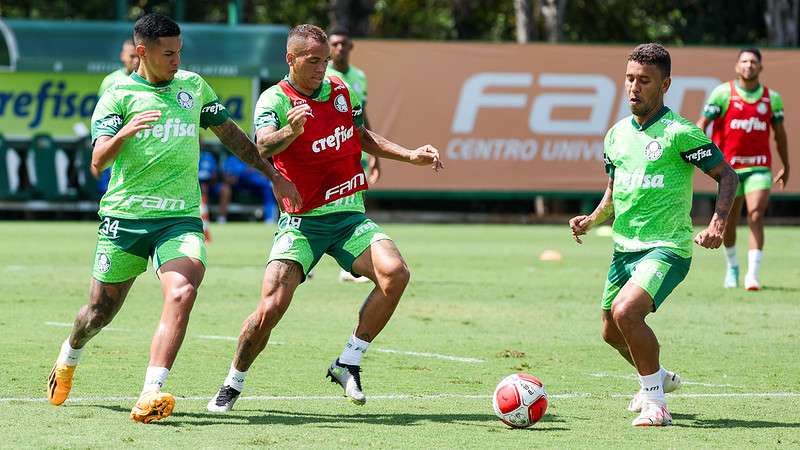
[92,217,206,283]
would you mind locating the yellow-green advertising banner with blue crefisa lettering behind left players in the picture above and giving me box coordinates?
[0,72,254,140]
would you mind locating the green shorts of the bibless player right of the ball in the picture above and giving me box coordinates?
[602,247,692,311]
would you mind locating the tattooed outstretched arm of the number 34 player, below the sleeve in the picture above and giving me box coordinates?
[209,119,302,212]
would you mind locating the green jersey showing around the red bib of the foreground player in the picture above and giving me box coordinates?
[253,77,364,216]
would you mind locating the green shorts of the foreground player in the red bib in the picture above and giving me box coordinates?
[268,212,391,276]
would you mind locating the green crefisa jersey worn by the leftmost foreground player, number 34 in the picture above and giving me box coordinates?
[92,70,229,219]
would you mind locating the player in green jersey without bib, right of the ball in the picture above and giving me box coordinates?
[569,44,737,426]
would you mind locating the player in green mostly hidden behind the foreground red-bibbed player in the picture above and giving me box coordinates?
[325,28,381,283]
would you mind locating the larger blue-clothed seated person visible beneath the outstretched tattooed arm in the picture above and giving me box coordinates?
[217,155,280,223]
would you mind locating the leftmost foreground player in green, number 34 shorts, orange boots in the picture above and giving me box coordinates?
[47,14,299,423]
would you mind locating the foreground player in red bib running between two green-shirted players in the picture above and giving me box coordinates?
[208,25,442,412]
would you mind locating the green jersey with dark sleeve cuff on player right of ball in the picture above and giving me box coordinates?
[605,107,723,258]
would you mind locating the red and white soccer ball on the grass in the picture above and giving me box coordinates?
[492,373,547,428]
